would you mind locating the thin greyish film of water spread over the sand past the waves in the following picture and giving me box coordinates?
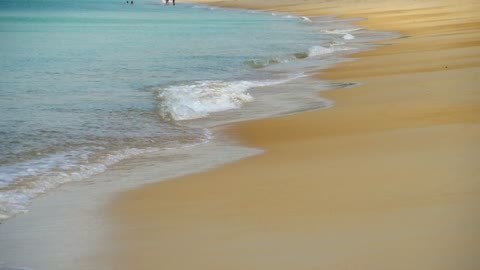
[0,3,399,269]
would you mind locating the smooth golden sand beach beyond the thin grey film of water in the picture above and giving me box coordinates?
[109,0,480,270]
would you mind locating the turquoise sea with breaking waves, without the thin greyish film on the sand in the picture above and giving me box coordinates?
[0,0,402,220]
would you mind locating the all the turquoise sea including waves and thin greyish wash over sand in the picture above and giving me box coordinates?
[0,0,404,270]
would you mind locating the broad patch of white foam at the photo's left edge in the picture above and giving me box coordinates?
[0,147,163,220]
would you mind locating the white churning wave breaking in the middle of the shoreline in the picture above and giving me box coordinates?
[156,79,300,121]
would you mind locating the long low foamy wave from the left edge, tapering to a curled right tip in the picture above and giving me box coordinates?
[0,124,213,221]
